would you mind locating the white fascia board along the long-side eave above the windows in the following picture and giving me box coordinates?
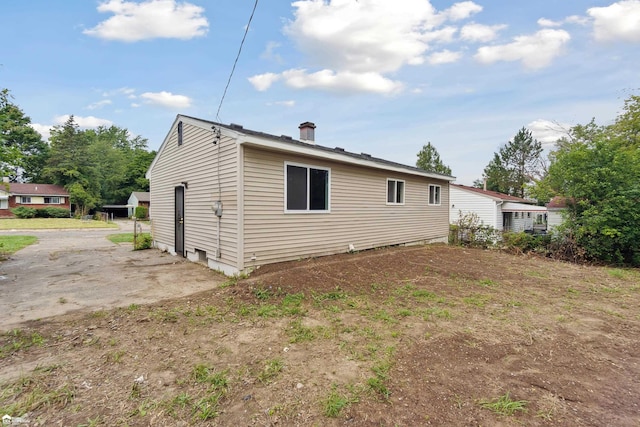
[237,134,455,182]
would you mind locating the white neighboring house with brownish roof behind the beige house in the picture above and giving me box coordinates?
[449,184,547,232]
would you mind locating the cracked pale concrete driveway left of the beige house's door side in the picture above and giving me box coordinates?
[0,221,225,330]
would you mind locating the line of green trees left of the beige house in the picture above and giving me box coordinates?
[0,89,156,215]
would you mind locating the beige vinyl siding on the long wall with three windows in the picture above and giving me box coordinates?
[243,147,449,267]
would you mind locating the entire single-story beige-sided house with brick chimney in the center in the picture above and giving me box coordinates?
[146,115,454,274]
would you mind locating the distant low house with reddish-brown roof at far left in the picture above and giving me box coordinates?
[0,182,71,218]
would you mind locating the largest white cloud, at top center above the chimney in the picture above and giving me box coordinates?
[249,0,482,94]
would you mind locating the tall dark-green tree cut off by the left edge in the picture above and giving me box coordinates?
[0,89,48,182]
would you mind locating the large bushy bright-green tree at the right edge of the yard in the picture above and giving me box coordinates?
[538,97,640,266]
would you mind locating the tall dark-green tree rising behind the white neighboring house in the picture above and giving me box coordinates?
[484,127,543,197]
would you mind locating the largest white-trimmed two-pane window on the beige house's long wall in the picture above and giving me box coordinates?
[284,162,331,212]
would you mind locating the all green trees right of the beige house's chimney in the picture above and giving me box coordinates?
[416,95,640,266]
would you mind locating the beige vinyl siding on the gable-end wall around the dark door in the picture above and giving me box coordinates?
[150,122,238,266]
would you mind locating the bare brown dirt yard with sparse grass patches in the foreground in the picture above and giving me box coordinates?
[0,246,640,426]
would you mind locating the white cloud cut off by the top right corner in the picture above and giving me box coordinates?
[587,0,640,42]
